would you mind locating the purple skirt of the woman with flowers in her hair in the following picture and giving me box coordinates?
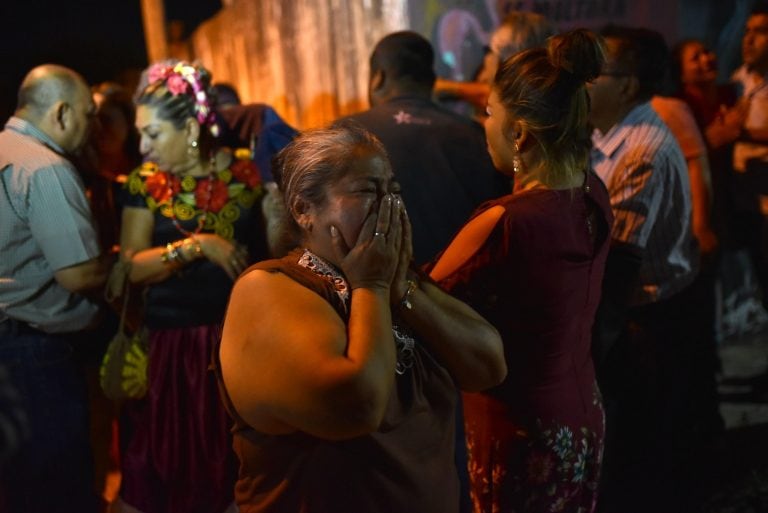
[120,325,237,513]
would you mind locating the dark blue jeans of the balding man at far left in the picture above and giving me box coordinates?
[0,320,98,513]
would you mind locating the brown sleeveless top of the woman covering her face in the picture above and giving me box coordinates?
[214,250,459,513]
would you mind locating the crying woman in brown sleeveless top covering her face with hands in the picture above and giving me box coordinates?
[219,126,506,513]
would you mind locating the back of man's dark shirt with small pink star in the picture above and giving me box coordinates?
[351,96,508,263]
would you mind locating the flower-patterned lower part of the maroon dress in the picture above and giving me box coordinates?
[464,394,604,513]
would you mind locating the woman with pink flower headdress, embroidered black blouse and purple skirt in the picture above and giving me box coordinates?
[114,62,264,513]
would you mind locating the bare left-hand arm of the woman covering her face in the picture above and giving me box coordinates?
[220,271,395,440]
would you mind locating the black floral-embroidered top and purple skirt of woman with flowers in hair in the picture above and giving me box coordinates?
[120,150,265,513]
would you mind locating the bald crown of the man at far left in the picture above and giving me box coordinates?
[16,64,88,122]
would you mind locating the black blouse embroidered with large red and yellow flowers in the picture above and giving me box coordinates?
[122,149,266,328]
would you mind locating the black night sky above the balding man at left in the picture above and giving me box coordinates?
[0,0,221,124]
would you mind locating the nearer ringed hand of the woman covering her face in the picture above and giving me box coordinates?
[330,194,402,289]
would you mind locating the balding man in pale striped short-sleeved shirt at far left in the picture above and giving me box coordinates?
[0,65,107,512]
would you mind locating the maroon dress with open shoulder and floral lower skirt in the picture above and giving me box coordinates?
[441,175,611,513]
